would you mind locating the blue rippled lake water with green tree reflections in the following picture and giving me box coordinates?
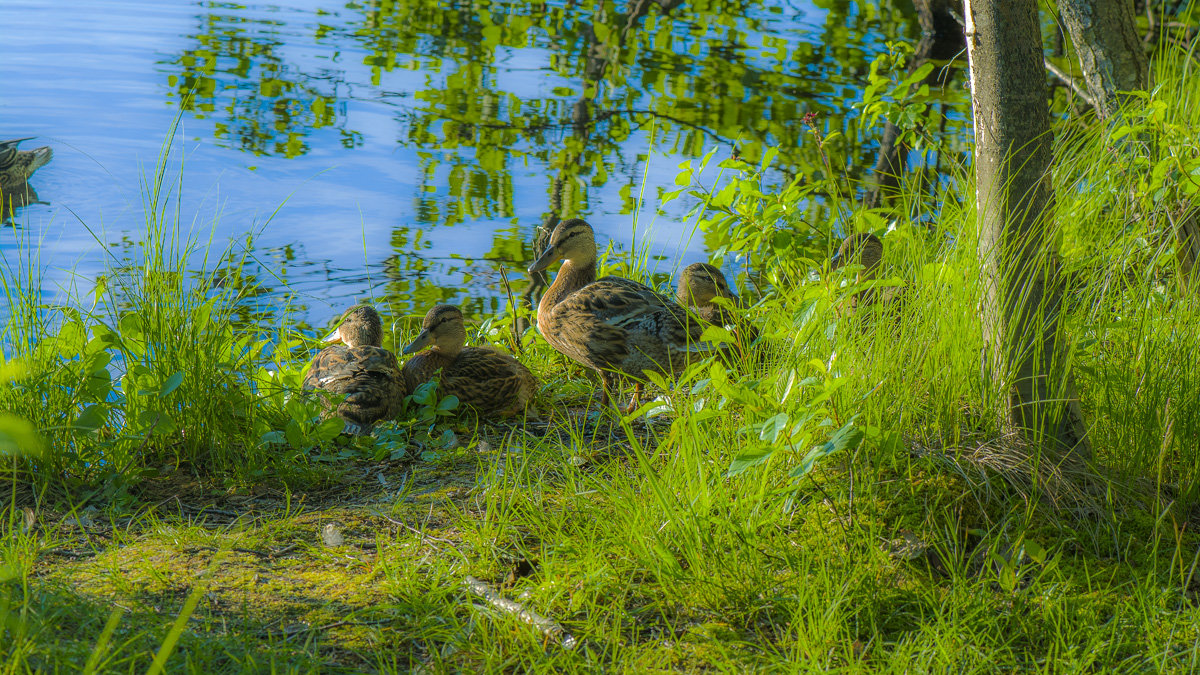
[0,0,916,323]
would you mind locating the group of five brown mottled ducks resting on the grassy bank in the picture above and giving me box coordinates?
[304,219,883,434]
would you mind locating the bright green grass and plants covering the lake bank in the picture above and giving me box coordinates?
[0,45,1200,673]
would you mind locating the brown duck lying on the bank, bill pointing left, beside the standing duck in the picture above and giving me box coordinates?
[402,305,539,419]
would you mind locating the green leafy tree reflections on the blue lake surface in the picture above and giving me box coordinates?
[169,0,953,311]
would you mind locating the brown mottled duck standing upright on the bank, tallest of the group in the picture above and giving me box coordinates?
[529,219,724,413]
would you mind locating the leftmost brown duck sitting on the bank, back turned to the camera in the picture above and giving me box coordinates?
[301,305,408,436]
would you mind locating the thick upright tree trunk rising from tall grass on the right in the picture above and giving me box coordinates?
[964,0,1091,458]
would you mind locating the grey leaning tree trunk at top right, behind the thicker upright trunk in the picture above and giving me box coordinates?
[1058,0,1150,119]
